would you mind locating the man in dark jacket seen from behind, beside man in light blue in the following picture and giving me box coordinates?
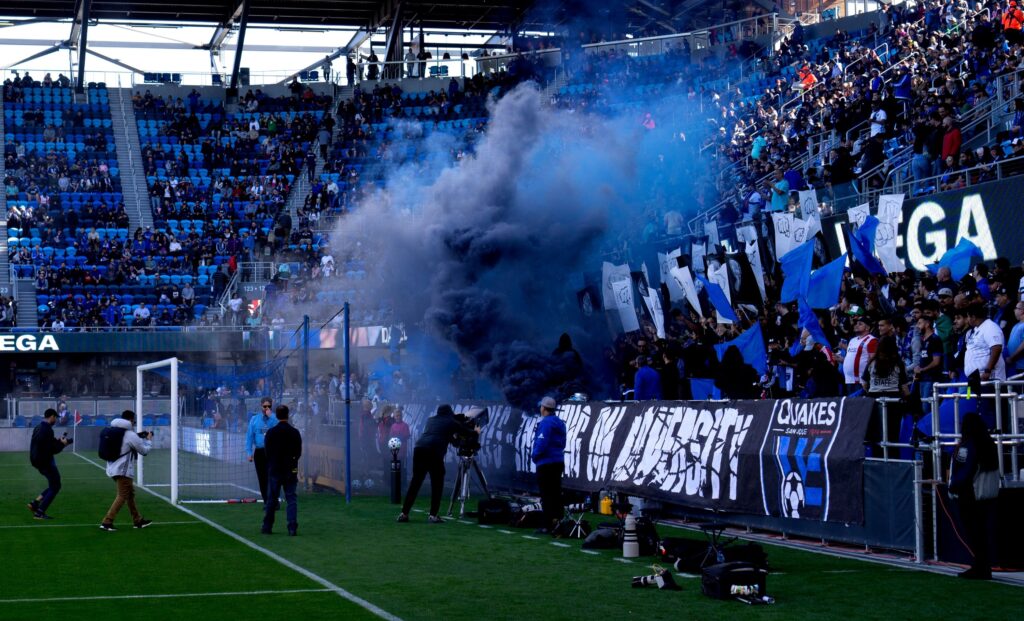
[262,406,302,537]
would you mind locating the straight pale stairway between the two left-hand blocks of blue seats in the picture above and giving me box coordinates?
[110,88,153,233]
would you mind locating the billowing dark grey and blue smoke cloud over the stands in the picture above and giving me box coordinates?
[332,84,712,409]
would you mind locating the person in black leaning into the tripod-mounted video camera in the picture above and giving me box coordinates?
[398,404,480,524]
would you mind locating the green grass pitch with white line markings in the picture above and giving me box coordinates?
[0,453,1024,621]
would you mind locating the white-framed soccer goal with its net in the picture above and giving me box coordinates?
[136,359,285,503]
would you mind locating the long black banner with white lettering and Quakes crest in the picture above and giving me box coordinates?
[406,398,873,523]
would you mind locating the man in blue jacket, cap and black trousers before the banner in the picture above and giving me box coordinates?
[531,397,565,535]
